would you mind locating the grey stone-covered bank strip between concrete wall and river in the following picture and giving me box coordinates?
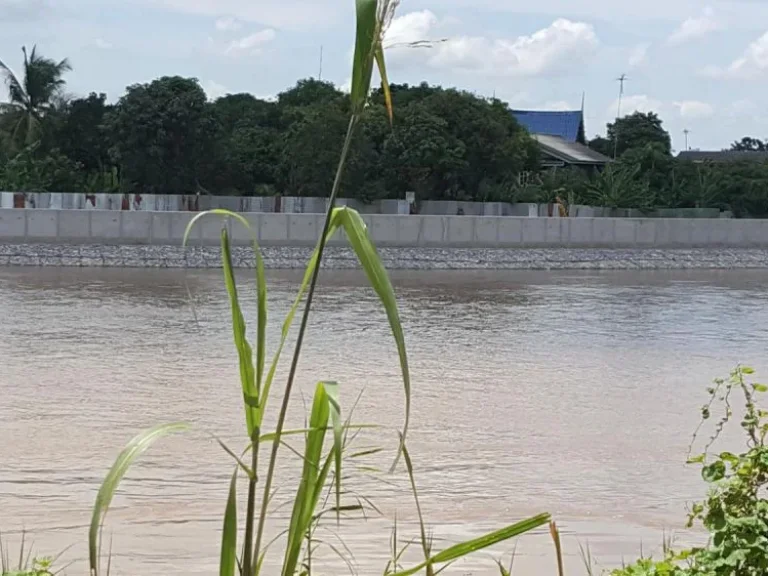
[0,244,768,270]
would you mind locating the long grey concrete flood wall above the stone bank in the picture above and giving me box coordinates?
[0,209,768,248]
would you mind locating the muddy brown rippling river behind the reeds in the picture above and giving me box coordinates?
[0,268,768,576]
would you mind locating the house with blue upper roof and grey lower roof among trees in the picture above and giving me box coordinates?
[512,110,611,169]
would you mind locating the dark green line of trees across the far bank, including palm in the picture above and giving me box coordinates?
[0,48,768,216]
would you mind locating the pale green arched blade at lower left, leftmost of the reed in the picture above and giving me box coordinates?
[88,423,189,576]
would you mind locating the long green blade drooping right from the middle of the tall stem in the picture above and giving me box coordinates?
[334,207,411,470]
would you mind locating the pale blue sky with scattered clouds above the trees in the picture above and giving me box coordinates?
[0,0,768,151]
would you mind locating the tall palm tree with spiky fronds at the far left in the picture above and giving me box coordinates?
[0,46,72,146]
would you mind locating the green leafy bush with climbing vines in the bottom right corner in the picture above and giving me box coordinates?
[613,367,768,576]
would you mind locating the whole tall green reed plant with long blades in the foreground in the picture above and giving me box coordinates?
[89,0,550,576]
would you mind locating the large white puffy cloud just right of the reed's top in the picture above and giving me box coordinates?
[387,10,599,77]
